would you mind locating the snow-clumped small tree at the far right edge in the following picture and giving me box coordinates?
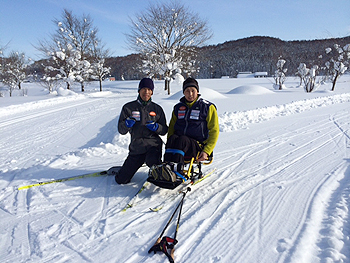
[325,44,350,91]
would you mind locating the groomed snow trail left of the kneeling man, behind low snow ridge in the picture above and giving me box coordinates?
[0,95,130,186]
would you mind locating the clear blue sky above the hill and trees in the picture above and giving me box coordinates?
[0,0,350,60]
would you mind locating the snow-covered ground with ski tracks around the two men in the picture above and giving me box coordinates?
[0,76,350,263]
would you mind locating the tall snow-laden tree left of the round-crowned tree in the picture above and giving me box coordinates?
[37,9,108,91]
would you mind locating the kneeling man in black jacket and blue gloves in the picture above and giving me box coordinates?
[115,78,168,184]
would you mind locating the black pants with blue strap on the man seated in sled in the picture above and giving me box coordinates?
[164,134,201,163]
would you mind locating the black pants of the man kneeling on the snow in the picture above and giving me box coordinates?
[115,147,162,184]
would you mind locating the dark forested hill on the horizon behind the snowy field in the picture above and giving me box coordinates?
[106,36,350,80]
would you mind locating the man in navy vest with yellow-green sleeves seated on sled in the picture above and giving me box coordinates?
[164,78,219,172]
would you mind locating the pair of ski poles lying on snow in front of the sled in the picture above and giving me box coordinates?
[148,187,191,263]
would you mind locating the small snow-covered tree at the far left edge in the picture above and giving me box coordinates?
[1,51,30,96]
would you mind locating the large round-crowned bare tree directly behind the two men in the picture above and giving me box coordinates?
[126,2,212,94]
